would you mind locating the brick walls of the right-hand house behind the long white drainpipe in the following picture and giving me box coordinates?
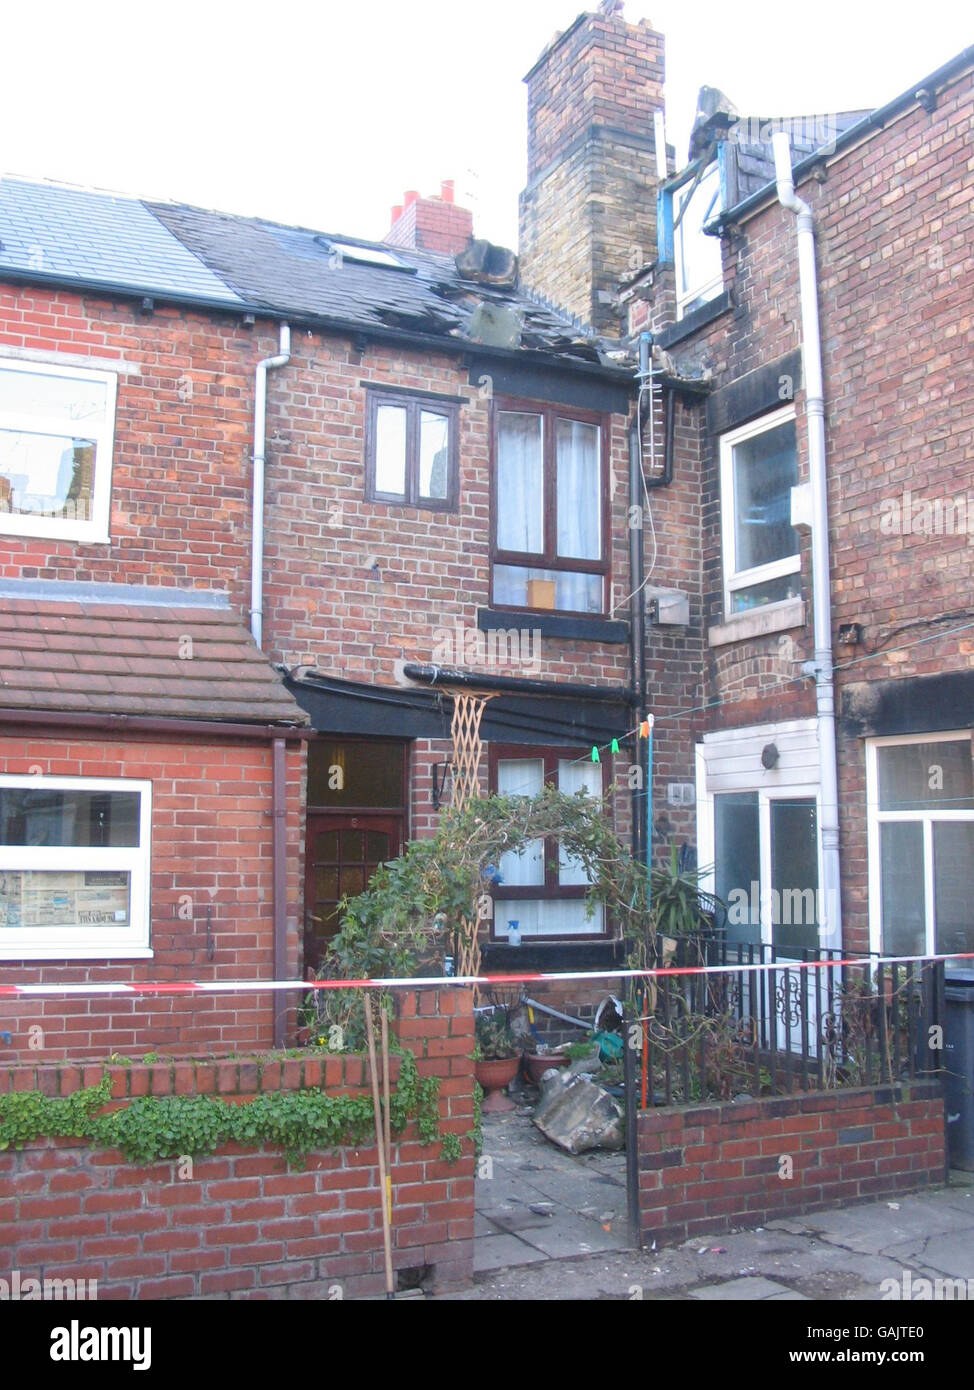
[631,72,974,949]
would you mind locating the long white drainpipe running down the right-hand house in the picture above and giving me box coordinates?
[771,131,842,949]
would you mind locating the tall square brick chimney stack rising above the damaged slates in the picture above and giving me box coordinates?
[518,13,663,335]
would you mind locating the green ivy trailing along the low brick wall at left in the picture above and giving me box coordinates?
[0,1052,447,1163]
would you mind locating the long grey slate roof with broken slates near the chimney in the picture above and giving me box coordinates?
[0,178,609,363]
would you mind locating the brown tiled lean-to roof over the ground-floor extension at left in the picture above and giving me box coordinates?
[0,585,307,726]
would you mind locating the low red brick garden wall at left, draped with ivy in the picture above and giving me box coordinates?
[0,988,474,1298]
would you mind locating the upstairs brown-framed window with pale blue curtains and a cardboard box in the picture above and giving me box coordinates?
[492,400,609,614]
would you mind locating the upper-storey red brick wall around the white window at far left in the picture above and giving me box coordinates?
[0,288,258,613]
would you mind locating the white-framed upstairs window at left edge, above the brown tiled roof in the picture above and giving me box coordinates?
[0,357,117,543]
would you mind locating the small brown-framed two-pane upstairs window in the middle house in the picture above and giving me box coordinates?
[365,391,459,512]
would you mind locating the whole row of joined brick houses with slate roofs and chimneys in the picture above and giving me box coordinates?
[0,2,974,1055]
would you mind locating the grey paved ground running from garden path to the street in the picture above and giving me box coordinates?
[439,1106,974,1302]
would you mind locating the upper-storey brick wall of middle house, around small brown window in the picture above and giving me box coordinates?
[264,332,628,685]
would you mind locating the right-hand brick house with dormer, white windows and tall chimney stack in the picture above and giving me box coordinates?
[522,15,974,956]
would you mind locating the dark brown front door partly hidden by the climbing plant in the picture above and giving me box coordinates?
[304,813,403,970]
